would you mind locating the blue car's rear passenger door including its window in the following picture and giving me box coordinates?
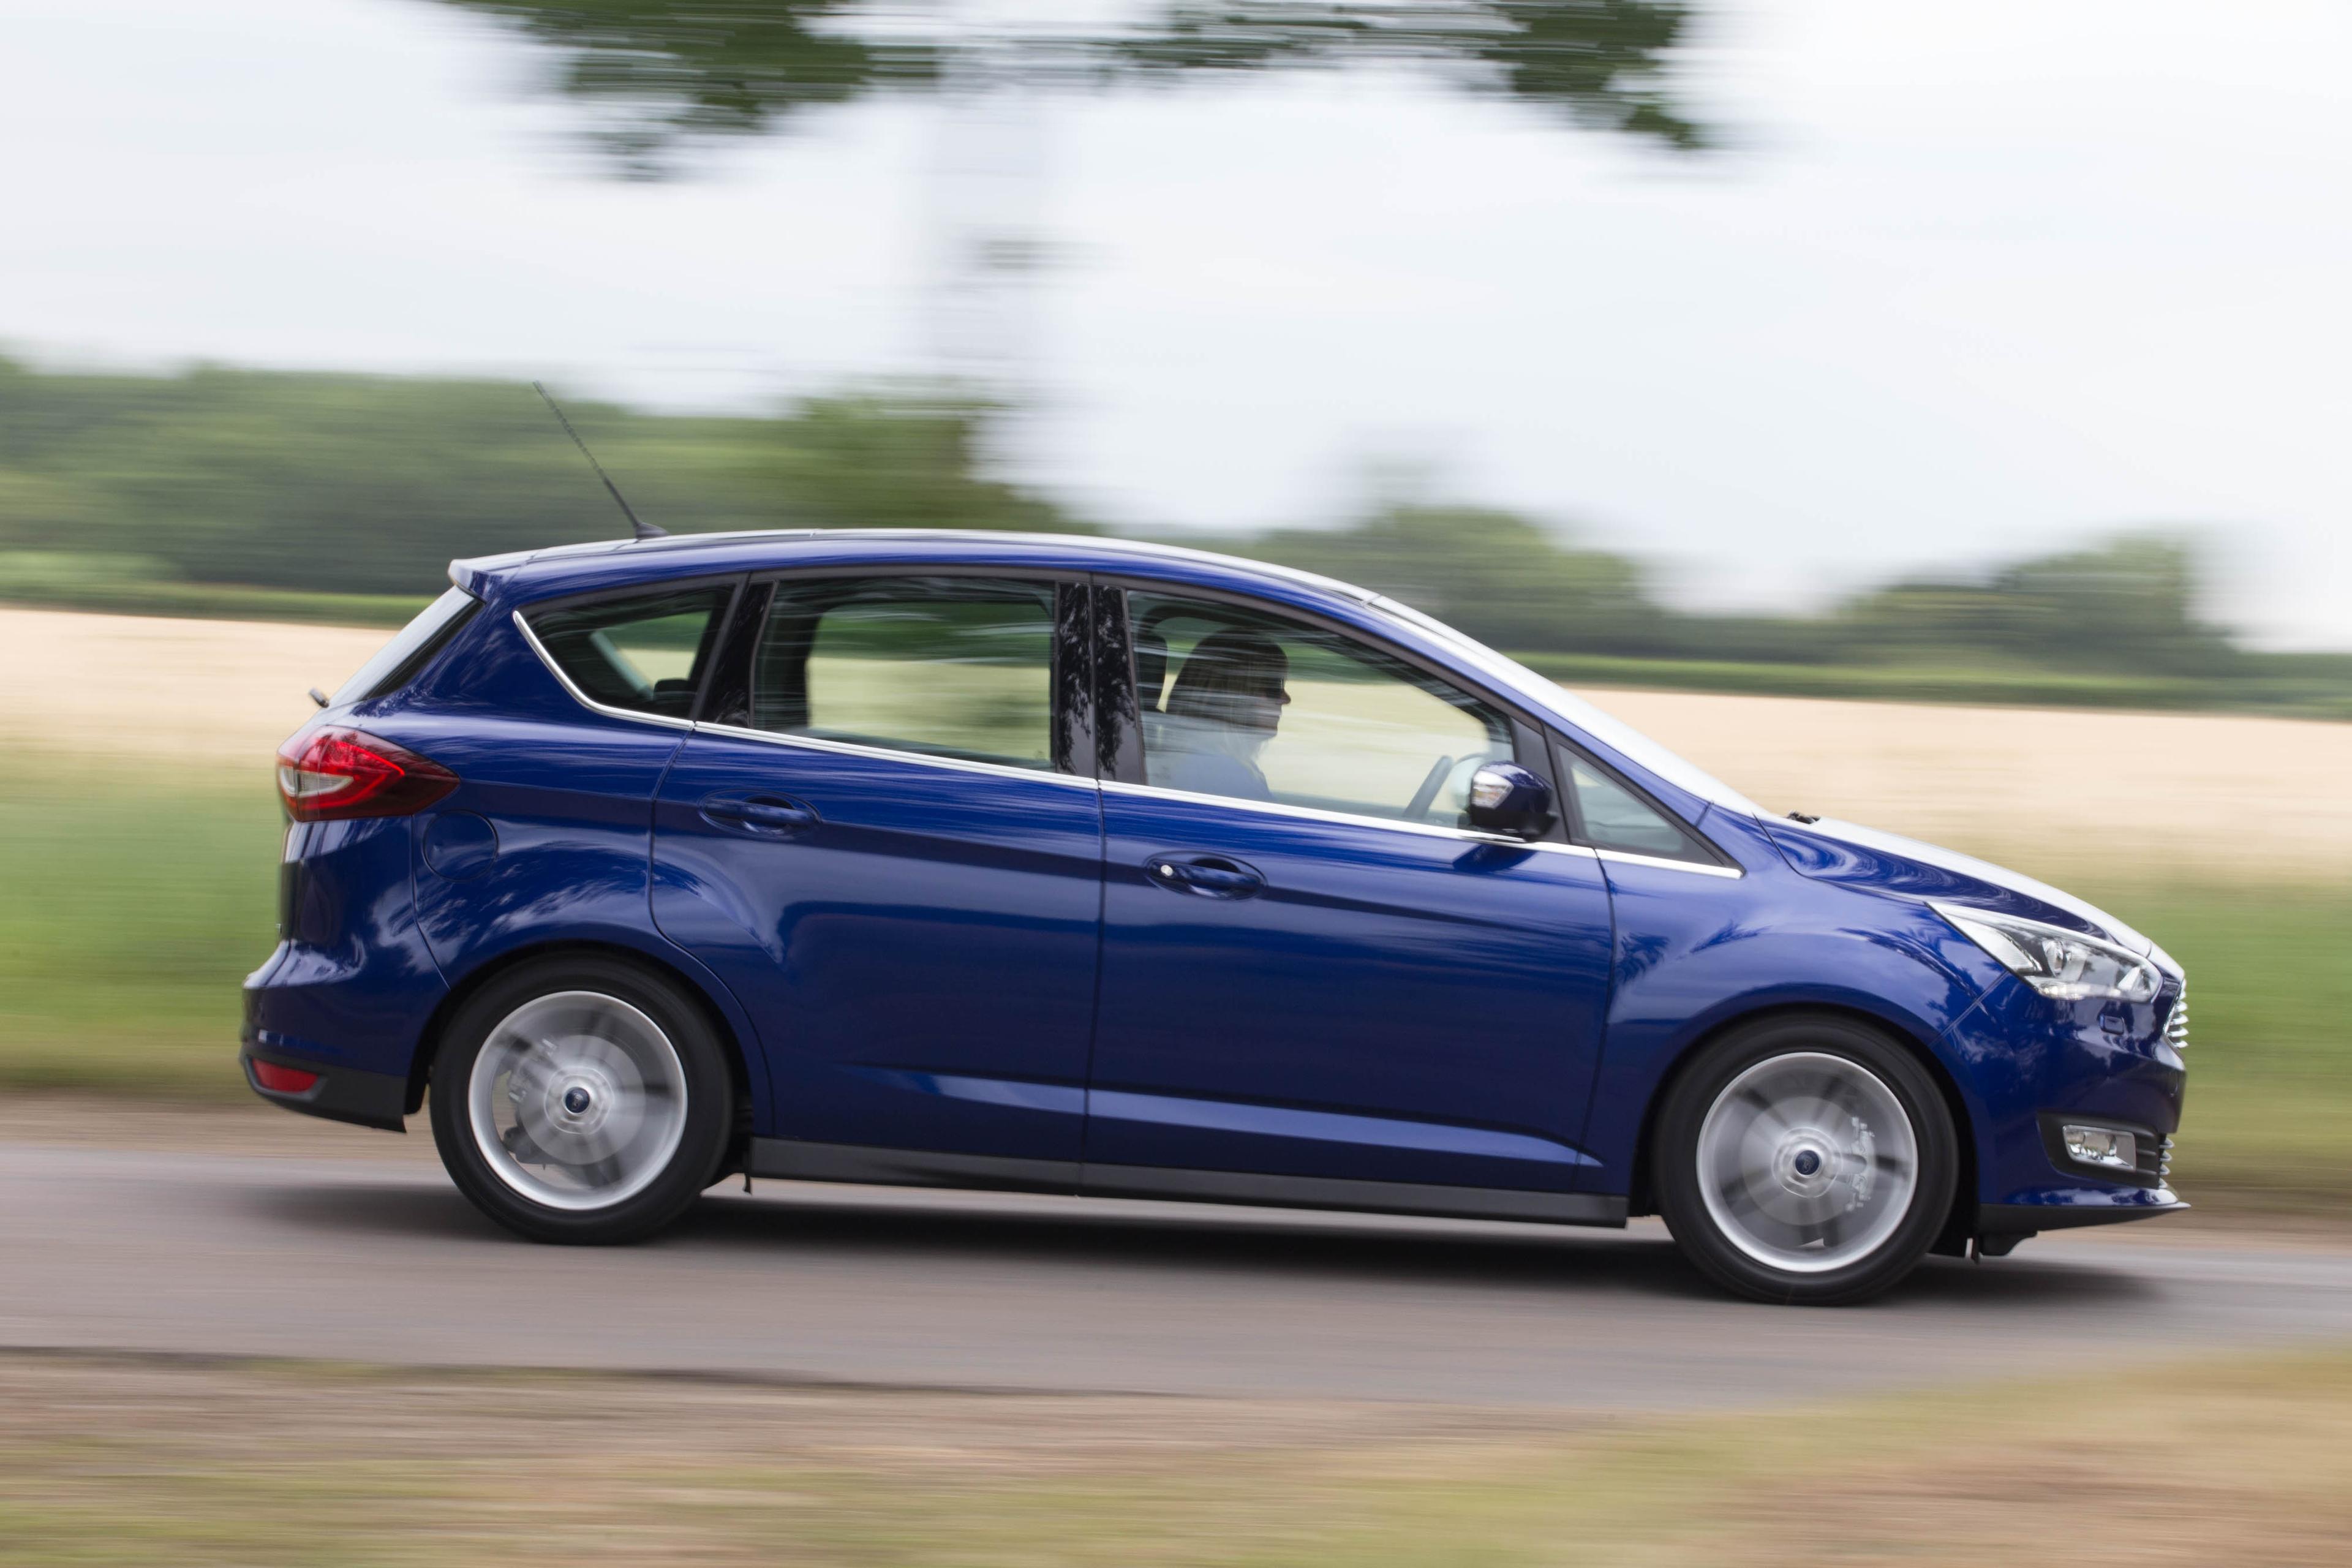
[654,569,1101,1166]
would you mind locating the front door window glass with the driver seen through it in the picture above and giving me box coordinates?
[1126,592,1512,827]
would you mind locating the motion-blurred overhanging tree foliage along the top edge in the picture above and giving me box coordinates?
[437,0,1700,176]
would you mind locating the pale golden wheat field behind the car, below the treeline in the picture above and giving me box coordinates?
[0,609,2352,884]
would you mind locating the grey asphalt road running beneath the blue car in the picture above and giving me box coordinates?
[0,1133,2352,1408]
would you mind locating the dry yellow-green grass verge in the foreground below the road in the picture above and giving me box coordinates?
[0,1354,2352,1568]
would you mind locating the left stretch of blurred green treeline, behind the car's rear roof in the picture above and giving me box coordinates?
[0,360,1077,592]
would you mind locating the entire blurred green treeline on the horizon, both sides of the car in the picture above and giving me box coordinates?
[0,360,2352,717]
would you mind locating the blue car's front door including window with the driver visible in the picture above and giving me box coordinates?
[1084,590,1611,1197]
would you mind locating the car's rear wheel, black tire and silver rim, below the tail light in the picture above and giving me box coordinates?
[433,962,734,1243]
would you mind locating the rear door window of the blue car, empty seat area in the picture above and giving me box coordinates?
[750,576,1054,771]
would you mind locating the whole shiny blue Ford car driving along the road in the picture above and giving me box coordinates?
[243,531,2187,1302]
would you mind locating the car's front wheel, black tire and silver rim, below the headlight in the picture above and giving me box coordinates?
[1651,1013,1959,1307]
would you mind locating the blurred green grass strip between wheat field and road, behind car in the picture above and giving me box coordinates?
[0,755,2352,1208]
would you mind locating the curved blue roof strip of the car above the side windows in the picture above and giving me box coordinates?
[449,529,1378,604]
